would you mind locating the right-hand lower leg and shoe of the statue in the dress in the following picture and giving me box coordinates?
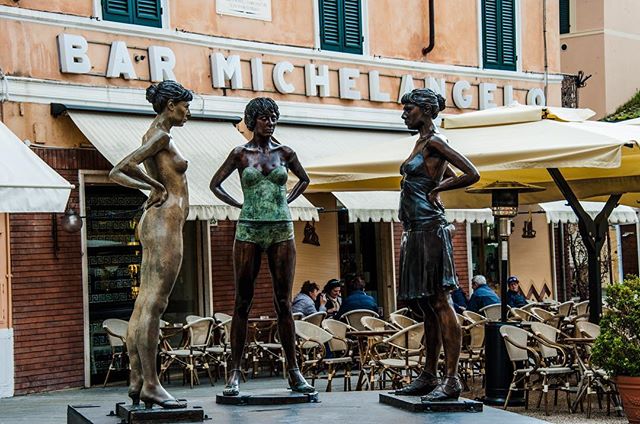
[423,289,462,401]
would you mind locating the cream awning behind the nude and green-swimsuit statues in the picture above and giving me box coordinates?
[69,111,318,221]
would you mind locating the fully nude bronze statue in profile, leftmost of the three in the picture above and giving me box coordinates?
[109,81,193,409]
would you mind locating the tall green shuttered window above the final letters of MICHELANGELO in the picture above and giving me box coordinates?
[482,0,518,71]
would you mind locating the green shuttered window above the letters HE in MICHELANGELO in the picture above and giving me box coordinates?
[319,0,362,54]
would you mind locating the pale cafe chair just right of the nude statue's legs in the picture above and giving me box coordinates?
[160,317,215,388]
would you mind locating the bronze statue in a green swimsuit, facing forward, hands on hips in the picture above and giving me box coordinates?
[210,97,315,396]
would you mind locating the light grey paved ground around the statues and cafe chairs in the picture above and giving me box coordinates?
[0,377,627,424]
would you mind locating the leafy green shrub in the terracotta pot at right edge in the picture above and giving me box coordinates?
[591,277,640,377]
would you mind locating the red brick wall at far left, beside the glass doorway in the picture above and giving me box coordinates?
[10,148,109,395]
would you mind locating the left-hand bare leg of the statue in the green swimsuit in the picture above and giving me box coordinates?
[223,240,262,396]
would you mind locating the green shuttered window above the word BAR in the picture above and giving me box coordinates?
[102,0,162,28]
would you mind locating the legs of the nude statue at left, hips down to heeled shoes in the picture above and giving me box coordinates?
[134,214,186,408]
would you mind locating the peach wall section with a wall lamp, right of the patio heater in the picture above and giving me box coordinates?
[509,214,555,300]
